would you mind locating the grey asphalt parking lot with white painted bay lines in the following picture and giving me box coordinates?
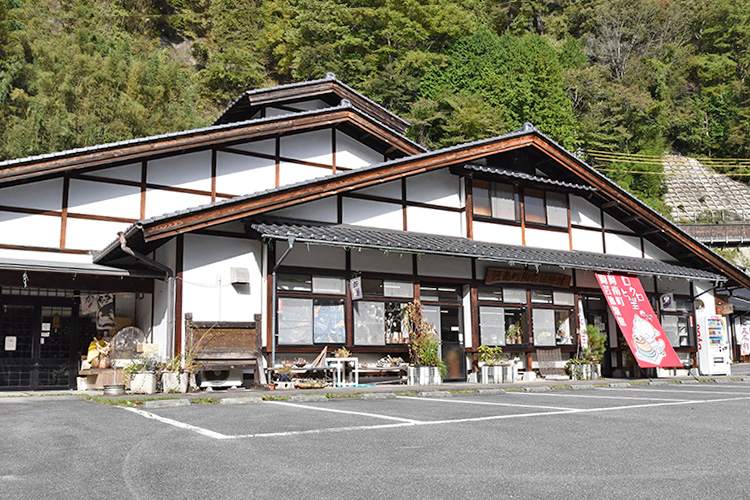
[0,381,750,499]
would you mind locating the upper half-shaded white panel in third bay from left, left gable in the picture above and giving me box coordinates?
[146,151,211,193]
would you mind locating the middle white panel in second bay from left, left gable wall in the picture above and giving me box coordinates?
[68,179,141,219]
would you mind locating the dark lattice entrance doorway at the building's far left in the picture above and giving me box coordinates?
[0,297,78,391]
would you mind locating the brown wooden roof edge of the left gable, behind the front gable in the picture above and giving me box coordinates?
[0,105,425,185]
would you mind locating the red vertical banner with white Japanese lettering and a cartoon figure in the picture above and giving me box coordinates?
[596,273,682,368]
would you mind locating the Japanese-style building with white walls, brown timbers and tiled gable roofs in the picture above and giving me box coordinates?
[0,75,750,389]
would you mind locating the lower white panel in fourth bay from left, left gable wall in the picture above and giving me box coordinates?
[216,151,276,195]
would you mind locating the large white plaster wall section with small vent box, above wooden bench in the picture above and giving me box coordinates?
[182,235,262,321]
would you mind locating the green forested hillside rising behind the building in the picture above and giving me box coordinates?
[0,0,750,212]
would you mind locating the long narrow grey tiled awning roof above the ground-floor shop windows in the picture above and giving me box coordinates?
[246,219,726,281]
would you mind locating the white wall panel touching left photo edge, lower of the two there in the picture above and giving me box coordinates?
[0,212,62,248]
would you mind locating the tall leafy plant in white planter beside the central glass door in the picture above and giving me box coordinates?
[405,301,447,385]
